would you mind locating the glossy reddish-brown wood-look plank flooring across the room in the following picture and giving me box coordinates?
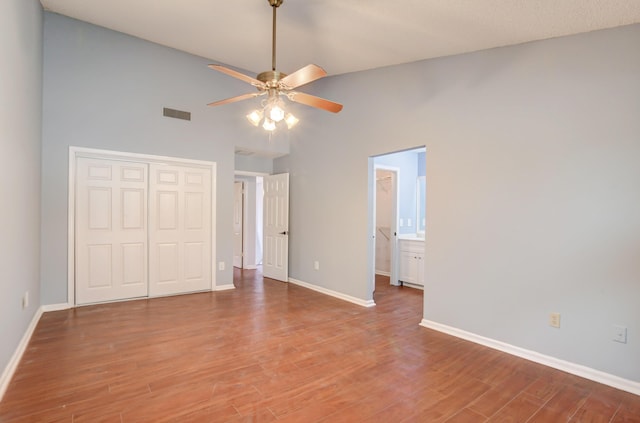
[0,270,640,423]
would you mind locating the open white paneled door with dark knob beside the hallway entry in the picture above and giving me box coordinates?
[262,173,289,282]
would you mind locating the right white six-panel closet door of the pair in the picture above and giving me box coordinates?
[149,163,211,297]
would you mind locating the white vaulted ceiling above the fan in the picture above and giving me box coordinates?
[41,0,640,75]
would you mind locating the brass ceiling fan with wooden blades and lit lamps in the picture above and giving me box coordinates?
[208,0,342,131]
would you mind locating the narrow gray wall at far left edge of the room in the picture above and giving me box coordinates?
[0,0,42,378]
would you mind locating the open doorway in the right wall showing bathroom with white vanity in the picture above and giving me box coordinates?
[368,147,426,298]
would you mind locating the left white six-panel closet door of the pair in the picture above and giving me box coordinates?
[75,158,148,304]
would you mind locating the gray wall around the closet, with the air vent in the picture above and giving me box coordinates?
[42,12,288,304]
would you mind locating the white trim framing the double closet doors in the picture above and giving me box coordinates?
[67,146,217,307]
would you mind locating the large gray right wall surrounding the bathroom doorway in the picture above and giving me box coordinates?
[286,25,640,381]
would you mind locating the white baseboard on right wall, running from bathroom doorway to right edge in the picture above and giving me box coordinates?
[420,319,640,395]
